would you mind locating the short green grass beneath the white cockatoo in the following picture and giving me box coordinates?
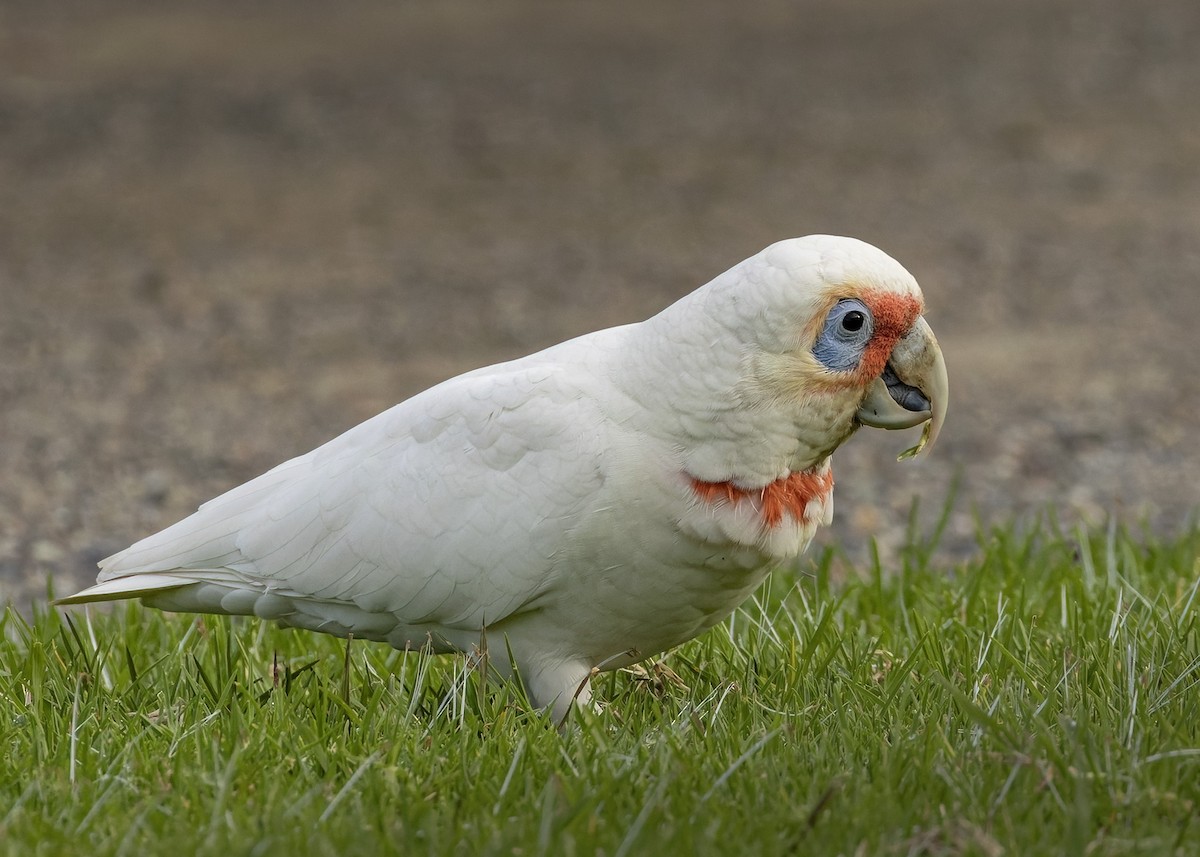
[0,513,1200,856]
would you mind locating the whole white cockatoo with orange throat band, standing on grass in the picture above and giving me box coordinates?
[61,235,948,719]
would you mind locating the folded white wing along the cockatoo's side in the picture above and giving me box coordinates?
[100,350,605,629]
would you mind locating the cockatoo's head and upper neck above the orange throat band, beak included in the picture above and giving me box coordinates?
[665,235,949,487]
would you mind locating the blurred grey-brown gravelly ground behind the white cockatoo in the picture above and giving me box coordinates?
[0,0,1200,603]
